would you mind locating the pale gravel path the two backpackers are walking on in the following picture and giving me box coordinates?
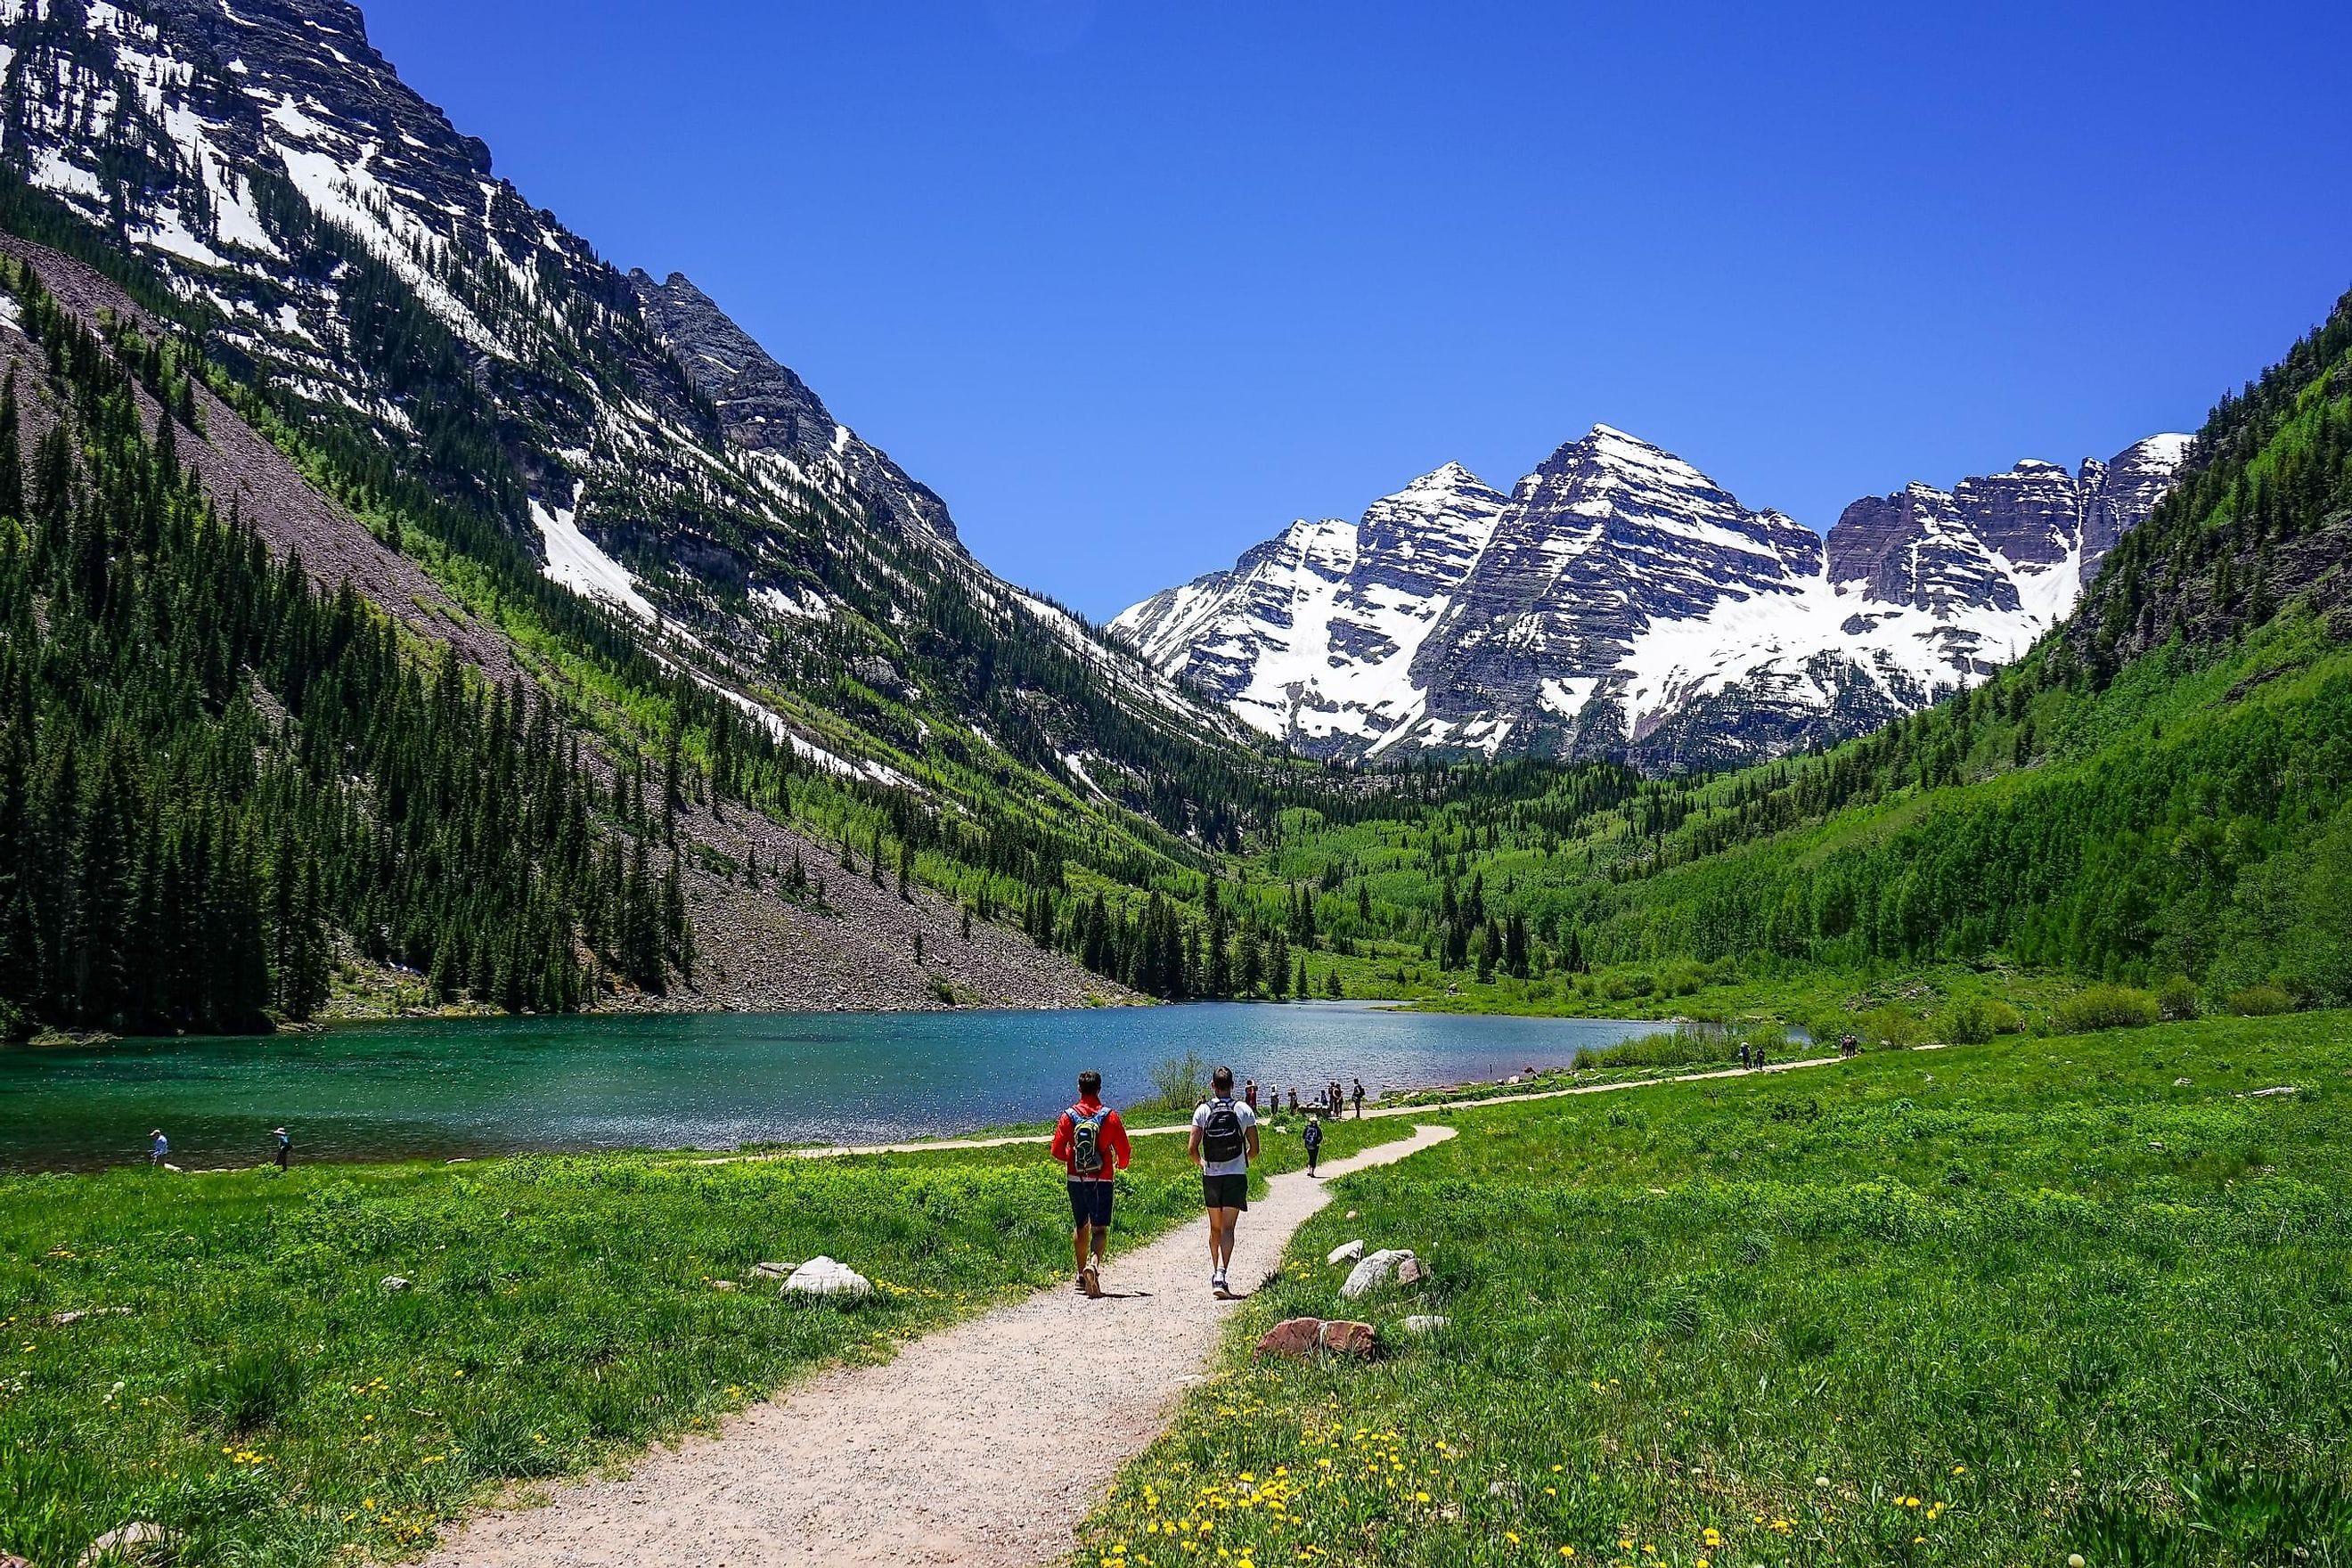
[426,1126,1454,1568]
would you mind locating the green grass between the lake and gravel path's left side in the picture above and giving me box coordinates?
[0,1122,1409,1568]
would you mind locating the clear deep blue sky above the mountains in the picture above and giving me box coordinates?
[367,0,2352,616]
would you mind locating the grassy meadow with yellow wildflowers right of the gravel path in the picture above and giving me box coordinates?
[1084,1013,2352,1568]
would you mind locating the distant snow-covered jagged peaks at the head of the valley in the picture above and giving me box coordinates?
[1110,426,2187,769]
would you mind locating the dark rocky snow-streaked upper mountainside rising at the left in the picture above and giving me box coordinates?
[0,0,1242,825]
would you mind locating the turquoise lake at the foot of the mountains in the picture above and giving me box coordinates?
[0,1001,1661,1171]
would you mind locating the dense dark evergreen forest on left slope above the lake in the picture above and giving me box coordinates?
[0,270,694,1032]
